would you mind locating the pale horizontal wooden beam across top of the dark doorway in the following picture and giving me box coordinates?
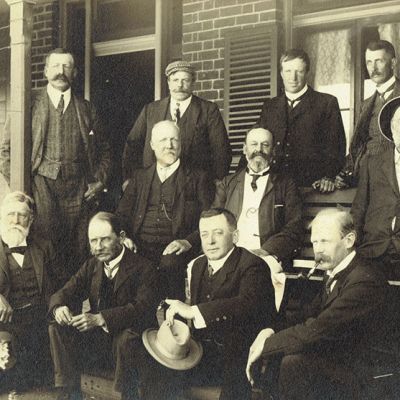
[93,35,155,57]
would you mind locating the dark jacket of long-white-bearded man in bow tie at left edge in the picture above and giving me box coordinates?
[0,236,58,303]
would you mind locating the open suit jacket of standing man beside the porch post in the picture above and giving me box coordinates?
[0,88,111,185]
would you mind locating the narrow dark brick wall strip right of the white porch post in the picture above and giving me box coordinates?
[32,0,59,89]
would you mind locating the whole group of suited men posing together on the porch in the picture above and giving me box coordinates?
[0,37,400,400]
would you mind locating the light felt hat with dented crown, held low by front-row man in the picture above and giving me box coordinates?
[142,320,203,371]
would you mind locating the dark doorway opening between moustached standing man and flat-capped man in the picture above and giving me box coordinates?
[91,50,154,210]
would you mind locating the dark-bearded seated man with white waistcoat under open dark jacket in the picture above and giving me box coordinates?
[213,128,303,264]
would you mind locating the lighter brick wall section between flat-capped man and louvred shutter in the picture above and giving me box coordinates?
[182,0,283,110]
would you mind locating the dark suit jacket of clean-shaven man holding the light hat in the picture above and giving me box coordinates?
[190,247,276,340]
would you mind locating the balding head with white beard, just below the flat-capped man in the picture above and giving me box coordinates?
[150,121,181,167]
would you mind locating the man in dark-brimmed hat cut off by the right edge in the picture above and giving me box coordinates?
[351,97,400,279]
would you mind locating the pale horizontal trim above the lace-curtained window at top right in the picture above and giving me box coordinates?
[293,0,400,28]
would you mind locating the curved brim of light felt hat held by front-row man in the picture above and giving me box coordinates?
[142,329,203,371]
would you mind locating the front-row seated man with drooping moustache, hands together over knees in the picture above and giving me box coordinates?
[49,212,159,400]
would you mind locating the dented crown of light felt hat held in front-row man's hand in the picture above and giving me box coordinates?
[156,320,190,360]
